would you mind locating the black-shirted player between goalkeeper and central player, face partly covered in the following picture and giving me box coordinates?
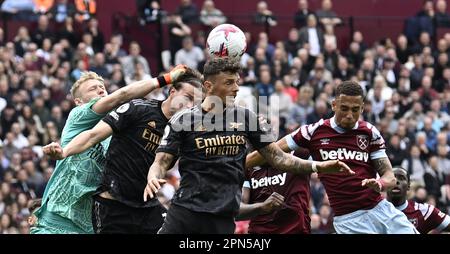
[45,69,202,234]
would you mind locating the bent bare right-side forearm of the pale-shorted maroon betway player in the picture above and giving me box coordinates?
[361,157,397,192]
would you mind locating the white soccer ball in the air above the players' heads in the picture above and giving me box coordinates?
[206,24,247,58]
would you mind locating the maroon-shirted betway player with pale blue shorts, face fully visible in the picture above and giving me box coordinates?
[247,81,417,234]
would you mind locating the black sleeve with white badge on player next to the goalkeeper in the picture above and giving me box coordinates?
[102,101,139,133]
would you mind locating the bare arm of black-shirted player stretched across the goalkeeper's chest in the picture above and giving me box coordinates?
[42,120,113,160]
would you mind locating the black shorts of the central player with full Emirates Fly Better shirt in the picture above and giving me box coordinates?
[158,204,236,234]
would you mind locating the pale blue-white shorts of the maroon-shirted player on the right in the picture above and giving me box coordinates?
[333,199,419,234]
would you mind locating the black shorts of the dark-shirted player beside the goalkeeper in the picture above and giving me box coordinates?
[92,195,167,234]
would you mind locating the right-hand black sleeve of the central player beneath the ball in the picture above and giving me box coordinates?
[246,110,276,150]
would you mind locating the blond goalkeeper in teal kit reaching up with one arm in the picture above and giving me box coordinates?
[31,66,186,234]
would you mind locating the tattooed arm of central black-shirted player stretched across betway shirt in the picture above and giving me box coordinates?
[258,143,355,175]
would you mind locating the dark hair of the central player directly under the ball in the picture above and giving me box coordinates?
[203,57,242,80]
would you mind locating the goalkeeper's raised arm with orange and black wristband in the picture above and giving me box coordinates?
[92,65,189,114]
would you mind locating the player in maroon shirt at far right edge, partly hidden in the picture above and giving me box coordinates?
[387,167,450,234]
